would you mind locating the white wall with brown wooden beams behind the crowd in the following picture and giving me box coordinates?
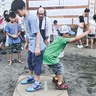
[26,0,96,25]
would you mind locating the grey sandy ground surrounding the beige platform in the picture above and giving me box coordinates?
[0,43,96,96]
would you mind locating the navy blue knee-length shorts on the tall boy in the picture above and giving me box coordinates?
[27,51,43,75]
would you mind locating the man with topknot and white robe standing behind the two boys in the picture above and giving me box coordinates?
[36,6,52,45]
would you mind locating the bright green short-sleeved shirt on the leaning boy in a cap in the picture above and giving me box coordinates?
[43,37,71,65]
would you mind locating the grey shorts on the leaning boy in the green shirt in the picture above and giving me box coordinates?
[48,63,64,75]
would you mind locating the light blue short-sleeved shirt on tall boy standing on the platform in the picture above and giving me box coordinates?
[23,13,46,53]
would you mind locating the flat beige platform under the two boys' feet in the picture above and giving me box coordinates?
[13,75,68,96]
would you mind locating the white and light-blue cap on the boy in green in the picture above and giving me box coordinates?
[59,25,75,35]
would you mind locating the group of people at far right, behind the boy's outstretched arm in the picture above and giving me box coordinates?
[76,8,96,49]
